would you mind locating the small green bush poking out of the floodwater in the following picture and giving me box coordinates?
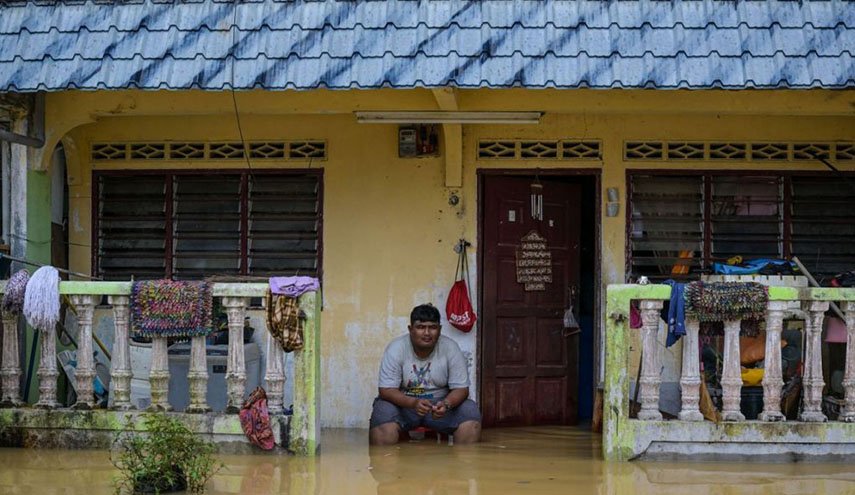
[111,413,223,493]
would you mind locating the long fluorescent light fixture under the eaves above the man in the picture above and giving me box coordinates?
[354,112,543,124]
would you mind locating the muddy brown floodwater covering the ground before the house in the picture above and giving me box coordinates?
[0,427,855,495]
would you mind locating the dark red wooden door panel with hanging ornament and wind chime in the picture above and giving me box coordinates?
[480,176,580,426]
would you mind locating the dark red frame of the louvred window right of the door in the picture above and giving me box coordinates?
[624,168,855,281]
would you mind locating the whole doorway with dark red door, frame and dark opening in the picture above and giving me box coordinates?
[479,170,599,426]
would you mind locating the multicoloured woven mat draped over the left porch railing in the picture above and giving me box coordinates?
[130,280,213,337]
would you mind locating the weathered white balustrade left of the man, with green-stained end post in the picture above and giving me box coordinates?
[0,281,320,455]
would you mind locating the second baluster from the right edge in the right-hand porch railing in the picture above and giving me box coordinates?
[804,301,828,423]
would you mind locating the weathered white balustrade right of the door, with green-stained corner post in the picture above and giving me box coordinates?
[603,285,855,460]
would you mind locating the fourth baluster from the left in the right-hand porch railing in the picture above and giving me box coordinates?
[760,301,788,421]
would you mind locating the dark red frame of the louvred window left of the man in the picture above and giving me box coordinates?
[90,168,324,280]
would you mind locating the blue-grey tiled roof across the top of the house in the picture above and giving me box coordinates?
[0,0,855,91]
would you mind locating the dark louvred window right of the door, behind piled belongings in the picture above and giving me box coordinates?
[627,171,855,280]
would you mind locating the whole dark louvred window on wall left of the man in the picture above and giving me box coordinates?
[93,171,322,280]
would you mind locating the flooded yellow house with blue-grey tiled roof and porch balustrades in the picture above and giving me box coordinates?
[0,0,855,468]
